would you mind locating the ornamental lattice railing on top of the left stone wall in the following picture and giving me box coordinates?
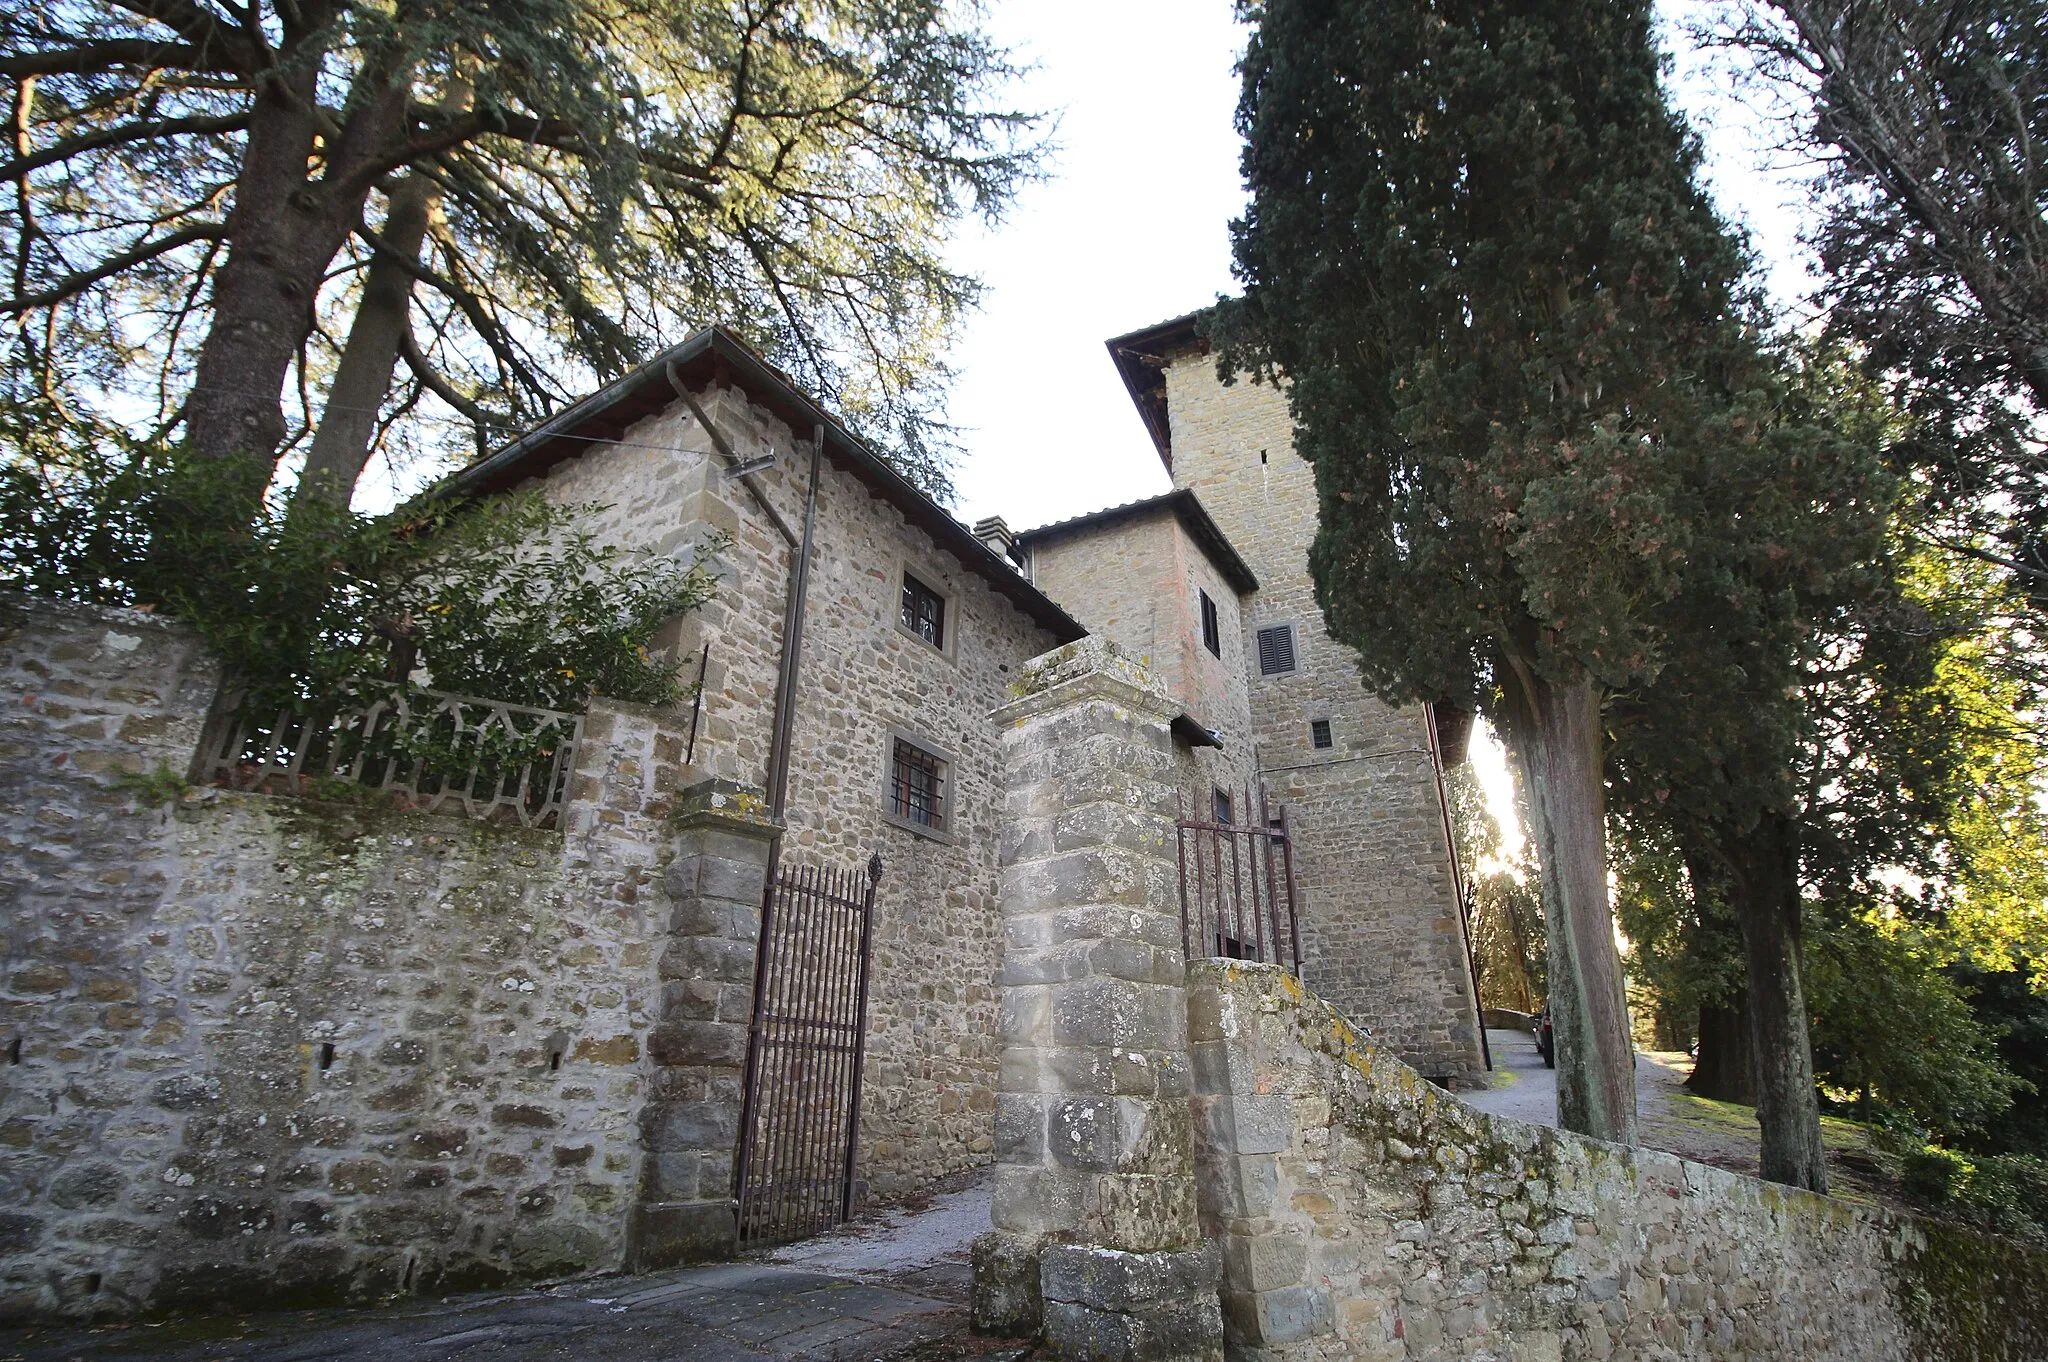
[199,680,584,827]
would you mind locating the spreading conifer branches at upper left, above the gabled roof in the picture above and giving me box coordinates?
[0,0,1040,492]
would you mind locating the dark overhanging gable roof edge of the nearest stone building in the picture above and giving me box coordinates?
[440,326,1087,643]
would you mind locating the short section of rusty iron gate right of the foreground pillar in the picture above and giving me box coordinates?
[1178,789,1300,979]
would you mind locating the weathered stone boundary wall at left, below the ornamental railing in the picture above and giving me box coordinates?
[0,598,678,1315]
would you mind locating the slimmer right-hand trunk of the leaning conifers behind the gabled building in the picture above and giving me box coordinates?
[293,174,434,508]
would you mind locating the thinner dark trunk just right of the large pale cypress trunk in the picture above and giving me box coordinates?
[1722,813,1827,1192]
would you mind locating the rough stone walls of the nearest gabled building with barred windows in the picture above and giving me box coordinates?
[520,387,1053,1200]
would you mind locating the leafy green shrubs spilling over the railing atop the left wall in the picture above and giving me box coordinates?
[0,444,717,711]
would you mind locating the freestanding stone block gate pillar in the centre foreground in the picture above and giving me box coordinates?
[975,639,1223,1362]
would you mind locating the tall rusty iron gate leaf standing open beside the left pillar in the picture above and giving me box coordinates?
[733,856,883,1243]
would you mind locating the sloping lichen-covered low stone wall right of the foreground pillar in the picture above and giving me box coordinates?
[1188,961,2048,1362]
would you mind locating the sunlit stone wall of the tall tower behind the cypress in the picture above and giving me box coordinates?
[1165,350,1483,1075]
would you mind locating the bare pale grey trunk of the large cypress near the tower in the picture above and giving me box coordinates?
[1503,670,1636,1145]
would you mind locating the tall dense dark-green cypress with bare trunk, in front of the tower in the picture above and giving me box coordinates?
[1210,0,1763,1143]
